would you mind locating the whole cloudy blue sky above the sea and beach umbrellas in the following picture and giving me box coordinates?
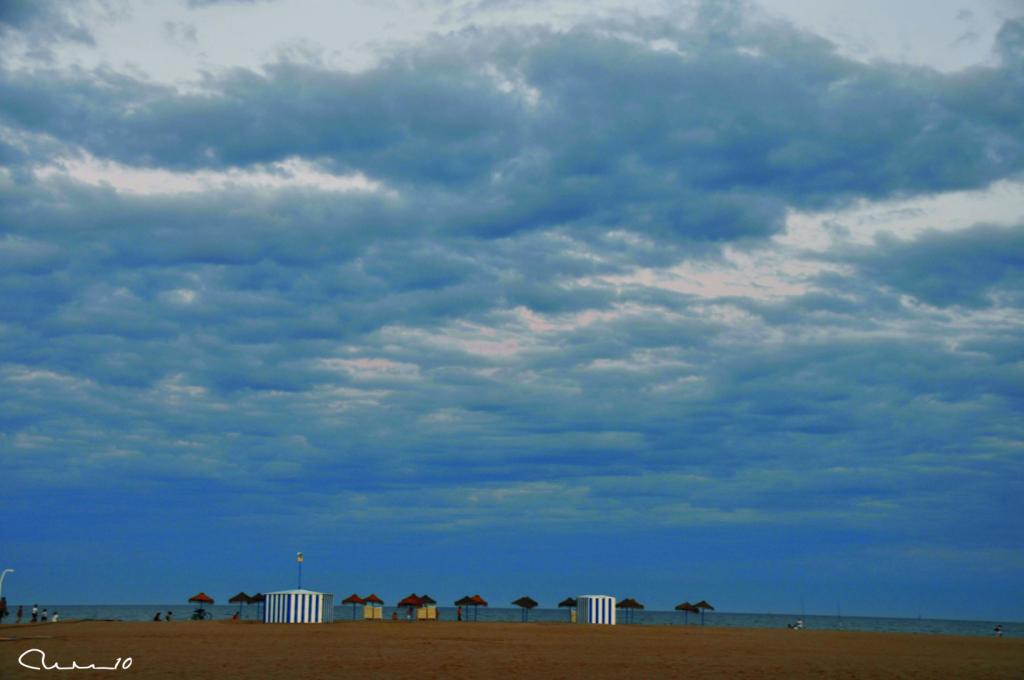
[0,0,1024,620]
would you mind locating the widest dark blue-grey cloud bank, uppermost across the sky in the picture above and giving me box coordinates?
[6,15,1024,248]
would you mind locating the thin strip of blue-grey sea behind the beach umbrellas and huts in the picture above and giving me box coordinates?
[16,602,1024,637]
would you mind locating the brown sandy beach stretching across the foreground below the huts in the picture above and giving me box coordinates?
[0,621,1024,680]
